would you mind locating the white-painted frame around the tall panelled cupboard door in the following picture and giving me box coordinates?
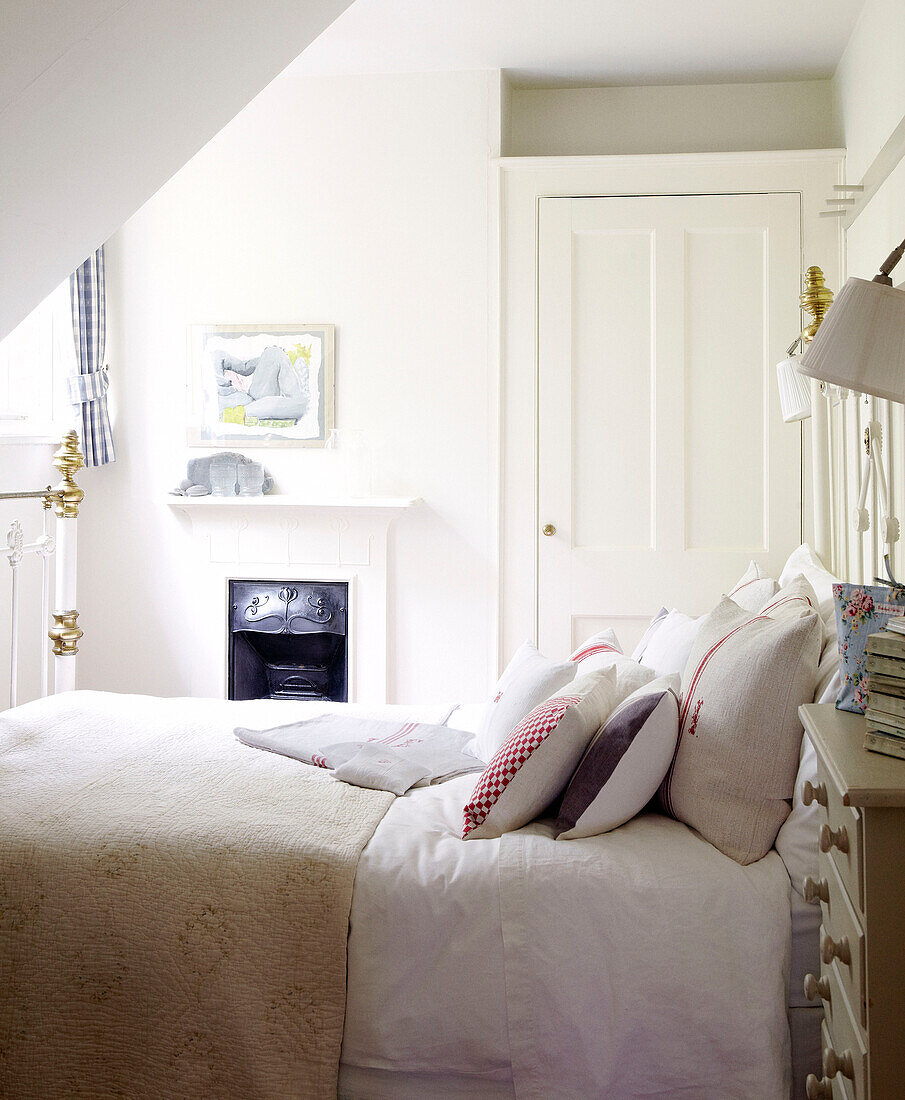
[493,150,845,667]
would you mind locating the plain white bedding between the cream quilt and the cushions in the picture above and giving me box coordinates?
[341,752,790,1100]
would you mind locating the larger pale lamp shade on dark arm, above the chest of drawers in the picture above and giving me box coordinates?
[799,278,905,402]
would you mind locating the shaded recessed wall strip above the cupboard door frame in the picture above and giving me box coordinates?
[504,80,840,156]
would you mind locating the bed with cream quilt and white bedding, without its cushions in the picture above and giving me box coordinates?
[0,440,820,1100]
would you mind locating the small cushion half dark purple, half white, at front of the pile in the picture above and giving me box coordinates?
[556,677,680,840]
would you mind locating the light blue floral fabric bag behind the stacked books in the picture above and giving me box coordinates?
[832,584,905,714]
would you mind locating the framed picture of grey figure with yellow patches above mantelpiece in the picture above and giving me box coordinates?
[188,325,333,448]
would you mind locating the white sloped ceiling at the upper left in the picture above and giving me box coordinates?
[0,0,350,339]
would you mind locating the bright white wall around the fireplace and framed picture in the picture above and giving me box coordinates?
[79,73,500,701]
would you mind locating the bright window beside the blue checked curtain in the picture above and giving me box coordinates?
[0,278,76,437]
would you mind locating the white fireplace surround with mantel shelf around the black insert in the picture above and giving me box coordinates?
[168,494,419,704]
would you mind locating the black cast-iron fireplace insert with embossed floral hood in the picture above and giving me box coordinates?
[228,580,349,703]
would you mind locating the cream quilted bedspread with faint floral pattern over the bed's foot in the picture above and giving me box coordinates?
[0,692,393,1100]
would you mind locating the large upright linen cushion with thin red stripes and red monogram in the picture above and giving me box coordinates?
[660,597,821,864]
